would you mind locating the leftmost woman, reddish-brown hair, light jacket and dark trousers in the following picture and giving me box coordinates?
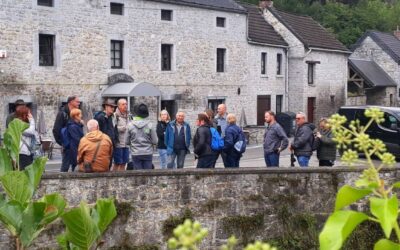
[15,106,35,170]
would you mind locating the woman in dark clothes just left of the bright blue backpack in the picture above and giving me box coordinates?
[193,113,215,168]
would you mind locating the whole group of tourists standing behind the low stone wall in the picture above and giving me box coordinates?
[6,96,336,172]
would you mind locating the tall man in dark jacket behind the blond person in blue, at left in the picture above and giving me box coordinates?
[53,96,81,173]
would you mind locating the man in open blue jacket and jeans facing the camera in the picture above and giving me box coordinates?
[165,111,191,168]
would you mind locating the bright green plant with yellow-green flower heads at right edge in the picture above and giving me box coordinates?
[319,108,400,250]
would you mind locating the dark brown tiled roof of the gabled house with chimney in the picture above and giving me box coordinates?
[268,7,350,53]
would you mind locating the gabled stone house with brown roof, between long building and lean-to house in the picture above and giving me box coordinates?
[260,1,350,122]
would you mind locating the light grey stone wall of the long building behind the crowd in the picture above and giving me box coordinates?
[0,0,287,133]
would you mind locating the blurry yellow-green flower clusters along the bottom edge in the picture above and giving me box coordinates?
[168,219,277,250]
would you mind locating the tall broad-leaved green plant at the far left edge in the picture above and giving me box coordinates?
[0,119,66,249]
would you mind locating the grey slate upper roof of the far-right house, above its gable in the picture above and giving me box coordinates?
[351,30,400,64]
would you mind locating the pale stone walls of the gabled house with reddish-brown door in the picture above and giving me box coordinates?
[264,10,348,122]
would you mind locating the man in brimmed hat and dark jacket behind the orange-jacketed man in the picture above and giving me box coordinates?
[94,99,117,147]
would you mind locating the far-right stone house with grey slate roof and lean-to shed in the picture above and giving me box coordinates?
[348,31,400,106]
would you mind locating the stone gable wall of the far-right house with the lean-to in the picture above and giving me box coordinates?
[350,36,400,106]
